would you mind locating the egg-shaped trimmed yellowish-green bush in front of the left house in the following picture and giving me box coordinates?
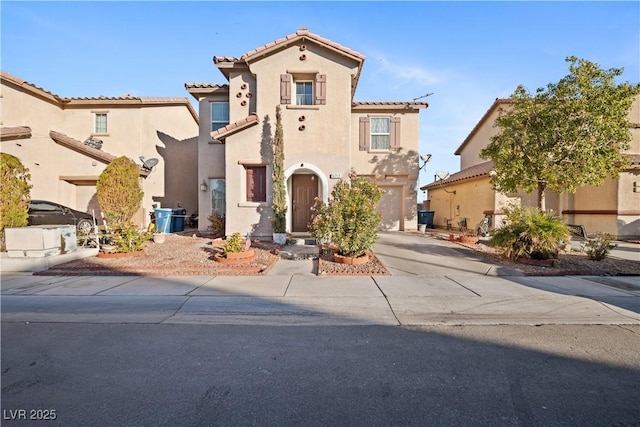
[96,156,144,227]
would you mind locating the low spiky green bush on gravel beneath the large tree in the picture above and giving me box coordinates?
[490,205,570,260]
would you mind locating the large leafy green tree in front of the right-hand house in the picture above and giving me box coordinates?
[481,56,640,210]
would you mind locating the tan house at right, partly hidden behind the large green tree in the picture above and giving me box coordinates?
[422,97,640,238]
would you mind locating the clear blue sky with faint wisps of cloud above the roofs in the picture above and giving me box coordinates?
[0,0,640,200]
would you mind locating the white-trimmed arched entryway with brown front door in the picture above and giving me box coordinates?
[285,163,328,233]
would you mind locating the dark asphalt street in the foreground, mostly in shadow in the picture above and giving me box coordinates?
[2,323,640,427]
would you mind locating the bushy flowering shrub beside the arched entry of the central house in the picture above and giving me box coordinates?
[309,173,383,257]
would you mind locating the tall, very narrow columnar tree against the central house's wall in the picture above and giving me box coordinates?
[271,105,287,233]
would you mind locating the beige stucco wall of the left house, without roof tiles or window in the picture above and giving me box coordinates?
[1,79,198,229]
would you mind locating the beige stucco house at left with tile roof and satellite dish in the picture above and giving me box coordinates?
[0,72,198,225]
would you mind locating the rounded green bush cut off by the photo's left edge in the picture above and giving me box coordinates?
[0,153,31,249]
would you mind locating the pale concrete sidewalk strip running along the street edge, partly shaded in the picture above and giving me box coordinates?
[1,272,640,326]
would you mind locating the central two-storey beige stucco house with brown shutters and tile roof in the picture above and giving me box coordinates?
[185,28,427,236]
